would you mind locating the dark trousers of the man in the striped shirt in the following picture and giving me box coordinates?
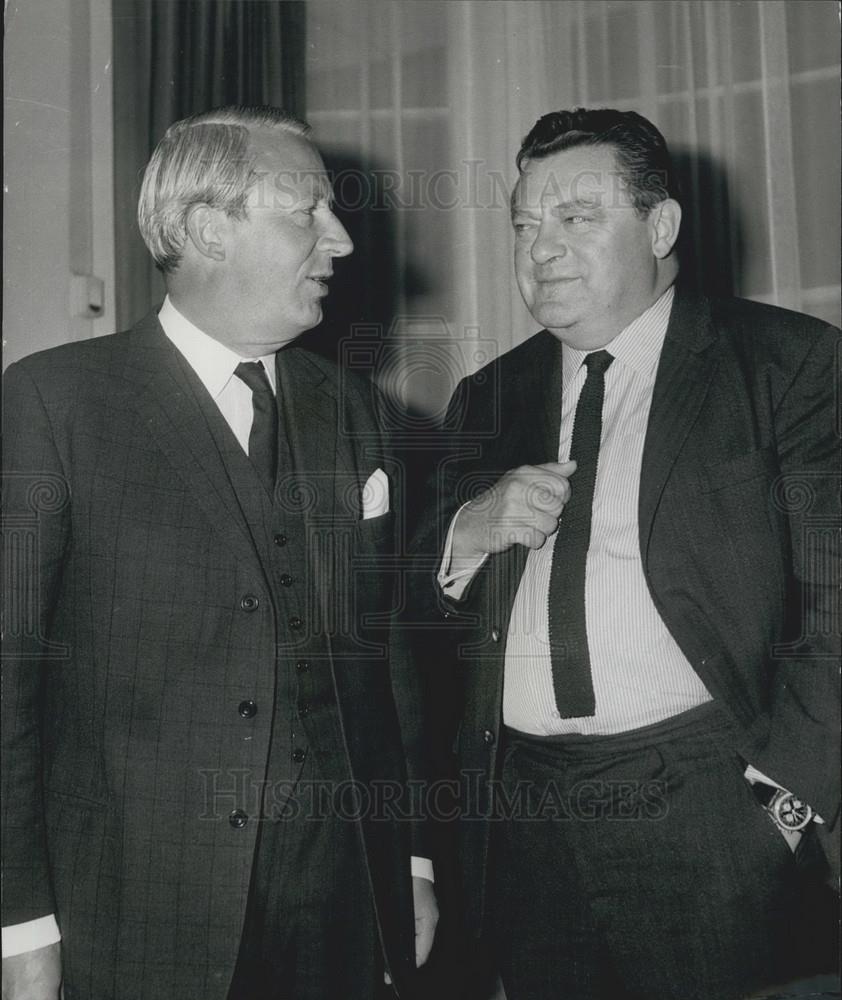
[489,703,828,1000]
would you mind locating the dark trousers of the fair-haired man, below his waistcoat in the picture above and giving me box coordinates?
[228,753,384,1000]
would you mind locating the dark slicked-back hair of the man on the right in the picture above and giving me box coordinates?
[517,108,681,217]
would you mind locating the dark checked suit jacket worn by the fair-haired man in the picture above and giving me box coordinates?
[2,317,421,1000]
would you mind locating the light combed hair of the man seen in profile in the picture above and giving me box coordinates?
[137,105,310,274]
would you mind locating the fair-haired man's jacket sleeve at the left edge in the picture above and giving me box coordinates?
[2,364,70,926]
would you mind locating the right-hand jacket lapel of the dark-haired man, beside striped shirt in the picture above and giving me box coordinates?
[639,287,719,562]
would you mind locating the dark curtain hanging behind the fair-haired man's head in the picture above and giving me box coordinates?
[112,0,305,329]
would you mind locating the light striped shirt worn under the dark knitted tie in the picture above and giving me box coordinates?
[503,288,710,736]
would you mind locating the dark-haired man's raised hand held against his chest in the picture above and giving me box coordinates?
[451,462,576,571]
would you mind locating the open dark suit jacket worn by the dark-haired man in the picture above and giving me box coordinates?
[406,289,840,931]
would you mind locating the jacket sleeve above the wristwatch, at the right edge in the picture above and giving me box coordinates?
[752,327,842,830]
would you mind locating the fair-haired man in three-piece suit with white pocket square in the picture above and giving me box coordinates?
[2,107,437,1000]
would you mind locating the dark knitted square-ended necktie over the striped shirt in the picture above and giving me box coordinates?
[548,351,614,719]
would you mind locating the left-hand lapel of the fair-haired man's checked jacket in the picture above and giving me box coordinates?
[124,314,257,576]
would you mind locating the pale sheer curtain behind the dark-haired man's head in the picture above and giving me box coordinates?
[306,0,842,417]
